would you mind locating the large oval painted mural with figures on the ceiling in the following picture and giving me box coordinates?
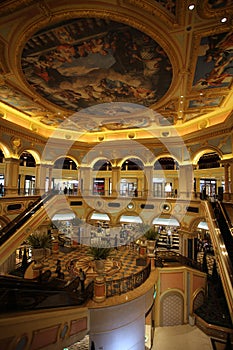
[22,18,172,111]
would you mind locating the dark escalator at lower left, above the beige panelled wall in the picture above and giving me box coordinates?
[0,276,93,315]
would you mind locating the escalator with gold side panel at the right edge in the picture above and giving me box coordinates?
[203,201,233,322]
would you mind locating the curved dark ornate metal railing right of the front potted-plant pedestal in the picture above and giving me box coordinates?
[106,261,151,298]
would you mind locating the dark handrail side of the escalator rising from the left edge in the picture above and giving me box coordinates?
[0,192,55,245]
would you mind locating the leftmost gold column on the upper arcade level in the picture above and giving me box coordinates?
[4,158,19,197]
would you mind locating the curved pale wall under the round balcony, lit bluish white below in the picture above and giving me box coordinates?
[89,293,146,350]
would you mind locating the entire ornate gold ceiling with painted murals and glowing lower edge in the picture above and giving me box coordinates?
[0,0,233,139]
